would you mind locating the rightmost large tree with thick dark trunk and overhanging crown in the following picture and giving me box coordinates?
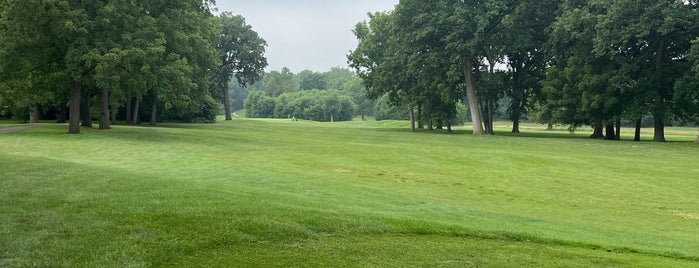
[594,0,697,142]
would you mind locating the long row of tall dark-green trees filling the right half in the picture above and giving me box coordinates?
[348,0,699,141]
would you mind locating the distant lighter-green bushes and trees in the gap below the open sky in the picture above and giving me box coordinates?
[237,67,375,121]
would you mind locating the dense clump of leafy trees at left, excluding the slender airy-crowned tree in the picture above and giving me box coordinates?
[0,0,216,130]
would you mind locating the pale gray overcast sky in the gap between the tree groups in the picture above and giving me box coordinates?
[216,0,399,73]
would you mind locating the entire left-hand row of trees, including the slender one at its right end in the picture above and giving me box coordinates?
[0,0,267,133]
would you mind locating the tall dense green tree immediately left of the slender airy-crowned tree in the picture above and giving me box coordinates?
[148,0,219,125]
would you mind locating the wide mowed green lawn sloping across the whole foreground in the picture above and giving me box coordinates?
[0,119,699,267]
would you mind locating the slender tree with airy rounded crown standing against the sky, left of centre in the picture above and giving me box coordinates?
[216,12,267,120]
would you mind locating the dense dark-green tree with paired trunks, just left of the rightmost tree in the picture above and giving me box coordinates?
[542,1,628,140]
